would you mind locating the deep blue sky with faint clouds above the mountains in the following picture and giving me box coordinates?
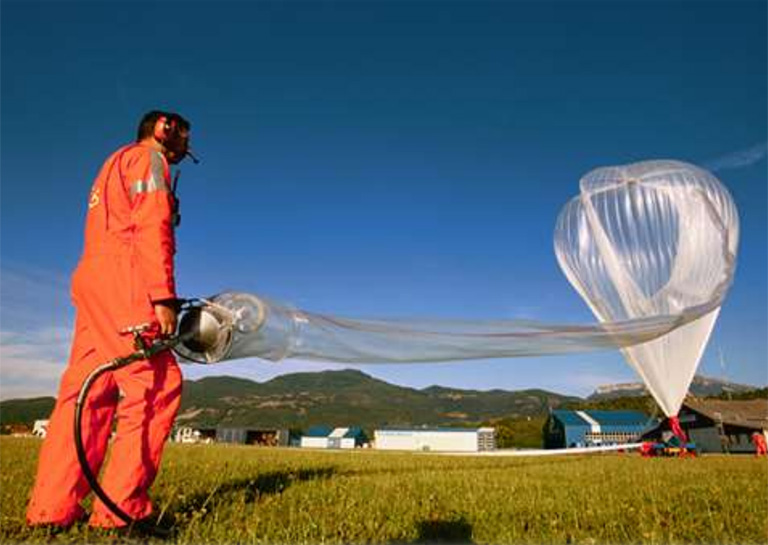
[0,0,768,398]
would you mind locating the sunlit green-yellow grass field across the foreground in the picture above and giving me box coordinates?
[0,438,768,544]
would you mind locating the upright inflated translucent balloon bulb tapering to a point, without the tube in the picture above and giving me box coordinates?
[555,161,739,416]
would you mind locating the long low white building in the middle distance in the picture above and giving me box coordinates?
[374,428,496,452]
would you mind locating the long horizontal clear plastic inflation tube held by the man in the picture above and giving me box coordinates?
[178,292,696,364]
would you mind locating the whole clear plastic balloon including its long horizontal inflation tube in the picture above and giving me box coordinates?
[177,161,738,414]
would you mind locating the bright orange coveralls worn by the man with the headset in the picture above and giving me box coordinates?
[27,144,181,527]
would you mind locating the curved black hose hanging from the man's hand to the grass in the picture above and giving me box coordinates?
[74,336,180,537]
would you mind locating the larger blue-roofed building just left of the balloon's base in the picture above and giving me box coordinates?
[544,410,655,448]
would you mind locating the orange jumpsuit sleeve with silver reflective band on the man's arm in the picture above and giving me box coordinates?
[127,150,176,302]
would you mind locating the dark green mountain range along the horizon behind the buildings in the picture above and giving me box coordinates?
[0,370,753,429]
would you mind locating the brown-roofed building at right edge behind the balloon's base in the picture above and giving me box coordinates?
[643,399,768,453]
